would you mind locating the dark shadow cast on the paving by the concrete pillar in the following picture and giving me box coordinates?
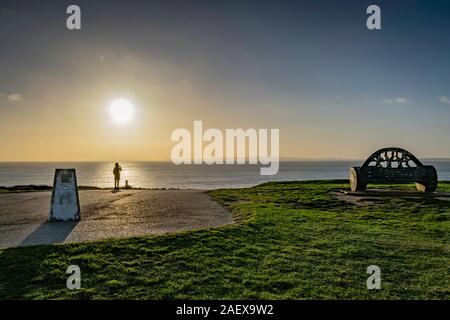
[19,221,78,247]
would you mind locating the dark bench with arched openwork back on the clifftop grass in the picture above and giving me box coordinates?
[350,148,438,192]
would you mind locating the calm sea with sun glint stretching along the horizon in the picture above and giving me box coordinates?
[0,159,450,189]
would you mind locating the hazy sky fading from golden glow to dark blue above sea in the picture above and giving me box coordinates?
[0,0,450,161]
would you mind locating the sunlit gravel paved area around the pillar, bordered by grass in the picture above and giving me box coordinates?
[0,190,233,247]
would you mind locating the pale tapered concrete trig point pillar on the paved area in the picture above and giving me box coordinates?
[48,169,81,221]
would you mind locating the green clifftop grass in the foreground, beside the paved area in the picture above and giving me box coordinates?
[0,181,450,299]
